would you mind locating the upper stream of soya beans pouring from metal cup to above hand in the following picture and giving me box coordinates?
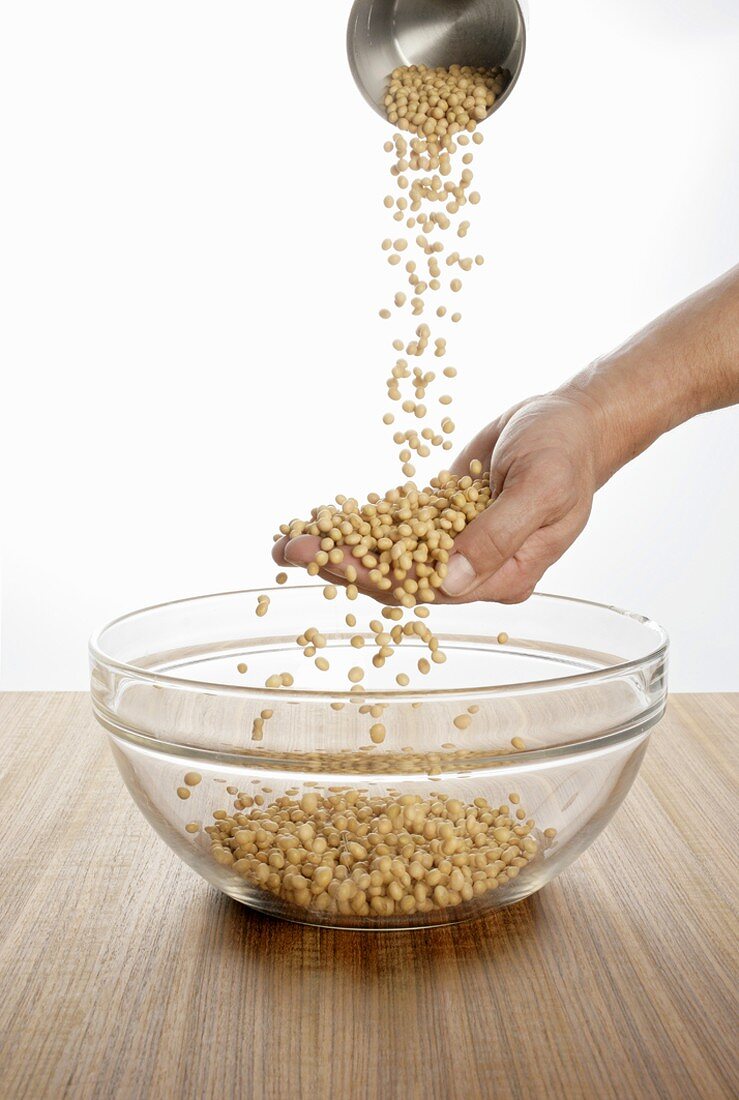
[379,65,507,477]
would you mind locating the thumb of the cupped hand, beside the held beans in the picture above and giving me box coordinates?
[441,482,545,597]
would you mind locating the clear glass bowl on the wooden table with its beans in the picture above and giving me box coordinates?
[90,584,668,928]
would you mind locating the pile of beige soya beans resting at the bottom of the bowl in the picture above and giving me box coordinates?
[186,788,555,917]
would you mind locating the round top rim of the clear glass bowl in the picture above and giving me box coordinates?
[88,583,670,702]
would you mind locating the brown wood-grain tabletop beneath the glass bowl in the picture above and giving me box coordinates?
[0,693,739,1100]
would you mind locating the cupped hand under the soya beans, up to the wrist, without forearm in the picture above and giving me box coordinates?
[273,394,598,603]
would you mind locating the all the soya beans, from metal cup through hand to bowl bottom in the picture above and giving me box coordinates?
[177,65,554,919]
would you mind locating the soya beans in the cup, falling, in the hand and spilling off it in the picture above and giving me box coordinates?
[266,65,508,745]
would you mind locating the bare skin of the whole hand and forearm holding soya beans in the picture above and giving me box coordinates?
[273,266,739,603]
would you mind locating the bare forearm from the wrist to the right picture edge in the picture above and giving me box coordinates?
[559,266,739,484]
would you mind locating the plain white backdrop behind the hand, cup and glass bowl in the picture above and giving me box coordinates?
[0,0,739,691]
